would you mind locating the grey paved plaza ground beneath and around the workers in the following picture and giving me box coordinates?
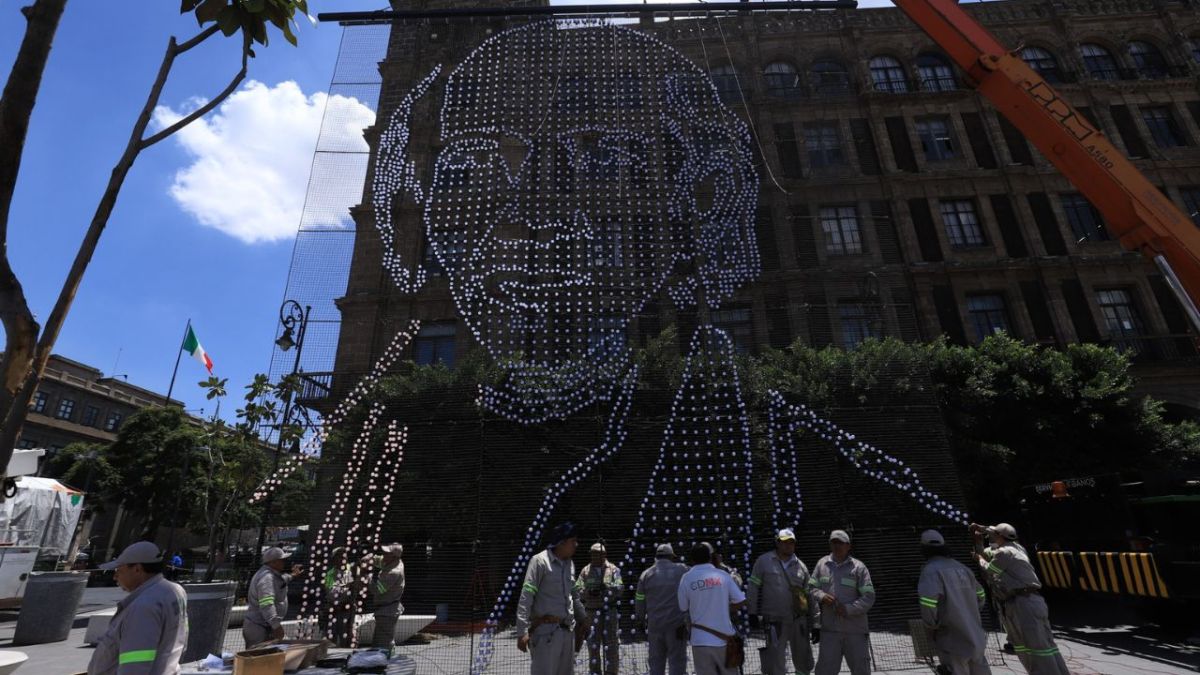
[0,589,1200,675]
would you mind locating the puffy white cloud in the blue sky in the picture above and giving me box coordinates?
[154,80,374,244]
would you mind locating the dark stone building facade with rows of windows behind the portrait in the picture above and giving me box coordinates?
[321,0,1200,414]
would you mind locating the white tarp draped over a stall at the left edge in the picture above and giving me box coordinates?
[0,476,83,556]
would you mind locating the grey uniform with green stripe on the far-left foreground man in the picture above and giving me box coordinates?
[88,574,187,675]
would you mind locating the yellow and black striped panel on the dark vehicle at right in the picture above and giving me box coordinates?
[1038,551,1170,598]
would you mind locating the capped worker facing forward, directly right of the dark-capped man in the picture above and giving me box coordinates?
[575,542,622,675]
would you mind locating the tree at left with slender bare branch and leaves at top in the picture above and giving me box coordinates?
[0,0,308,487]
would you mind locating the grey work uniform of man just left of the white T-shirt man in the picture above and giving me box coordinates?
[634,558,688,675]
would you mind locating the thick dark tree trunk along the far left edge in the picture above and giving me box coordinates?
[0,0,67,480]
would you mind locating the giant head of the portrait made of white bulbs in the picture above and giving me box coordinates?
[377,22,758,371]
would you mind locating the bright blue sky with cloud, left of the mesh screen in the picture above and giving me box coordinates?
[0,0,892,417]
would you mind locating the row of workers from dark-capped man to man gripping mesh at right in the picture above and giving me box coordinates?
[516,522,1069,675]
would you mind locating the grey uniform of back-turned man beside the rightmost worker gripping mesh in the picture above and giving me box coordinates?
[917,556,991,675]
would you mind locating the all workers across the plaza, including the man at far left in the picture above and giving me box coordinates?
[79,522,1069,675]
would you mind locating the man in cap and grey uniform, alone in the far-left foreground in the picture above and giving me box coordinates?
[88,542,187,675]
